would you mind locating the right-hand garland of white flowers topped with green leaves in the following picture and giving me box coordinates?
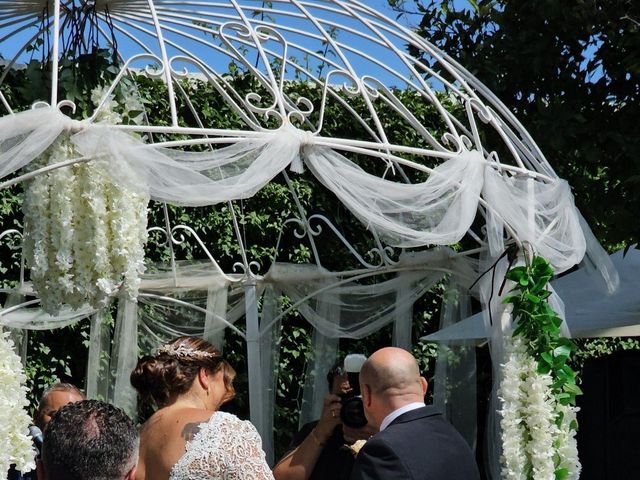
[498,257,582,480]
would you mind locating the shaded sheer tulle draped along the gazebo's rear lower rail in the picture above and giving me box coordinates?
[0,248,475,460]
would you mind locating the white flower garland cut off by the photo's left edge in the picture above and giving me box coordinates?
[0,328,36,476]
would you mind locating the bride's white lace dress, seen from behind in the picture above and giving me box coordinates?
[169,412,273,480]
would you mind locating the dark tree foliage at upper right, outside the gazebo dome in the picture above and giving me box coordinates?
[396,0,640,249]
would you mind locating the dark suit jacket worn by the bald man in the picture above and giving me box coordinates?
[351,406,480,480]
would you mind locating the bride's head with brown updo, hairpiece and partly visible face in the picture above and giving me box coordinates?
[131,337,236,410]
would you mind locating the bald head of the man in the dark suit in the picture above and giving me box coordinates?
[360,347,427,427]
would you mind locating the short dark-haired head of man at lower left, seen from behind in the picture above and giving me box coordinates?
[42,400,139,480]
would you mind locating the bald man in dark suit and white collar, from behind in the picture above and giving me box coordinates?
[351,347,480,480]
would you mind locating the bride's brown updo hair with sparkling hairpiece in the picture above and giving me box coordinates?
[131,337,236,407]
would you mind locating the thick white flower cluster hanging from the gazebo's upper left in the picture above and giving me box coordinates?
[23,88,149,314]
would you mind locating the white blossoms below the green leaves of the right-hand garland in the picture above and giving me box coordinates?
[498,335,580,480]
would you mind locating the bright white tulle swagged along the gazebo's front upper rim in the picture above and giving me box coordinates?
[0,107,585,273]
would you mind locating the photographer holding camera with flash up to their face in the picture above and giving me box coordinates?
[273,355,376,480]
